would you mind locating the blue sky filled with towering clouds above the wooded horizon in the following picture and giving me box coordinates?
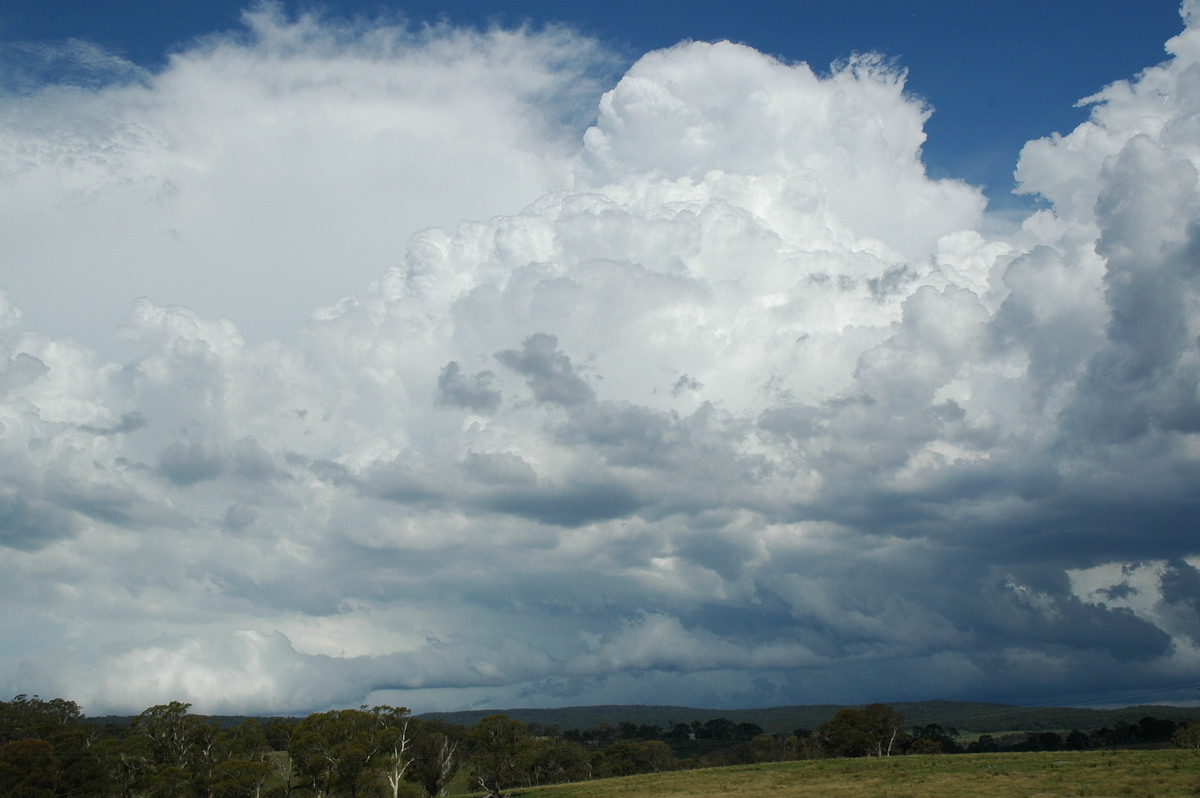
[0,0,1200,714]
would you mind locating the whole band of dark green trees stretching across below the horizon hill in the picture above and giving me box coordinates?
[0,695,1200,798]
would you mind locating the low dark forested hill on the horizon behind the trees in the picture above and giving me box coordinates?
[420,701,1200,734]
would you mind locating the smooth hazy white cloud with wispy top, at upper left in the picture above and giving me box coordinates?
[0,4,612,355]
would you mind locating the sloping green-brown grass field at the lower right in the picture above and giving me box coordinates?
[501,750,1200,798]
